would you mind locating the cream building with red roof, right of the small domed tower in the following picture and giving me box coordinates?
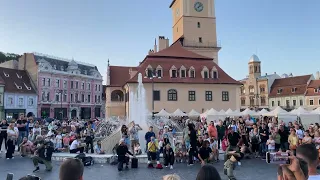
[269,75,314,111]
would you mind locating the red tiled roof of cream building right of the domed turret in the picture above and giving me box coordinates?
[269,75,312,97]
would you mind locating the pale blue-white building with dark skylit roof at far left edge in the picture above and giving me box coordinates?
[0,68,38,120]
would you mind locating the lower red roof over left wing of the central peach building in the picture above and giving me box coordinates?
[107,66,136,87]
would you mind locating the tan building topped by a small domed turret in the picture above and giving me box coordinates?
[240,55,280,110]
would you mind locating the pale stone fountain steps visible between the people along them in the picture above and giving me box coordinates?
[52,150,224,164]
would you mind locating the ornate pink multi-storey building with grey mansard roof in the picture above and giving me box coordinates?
[19,53,102,119]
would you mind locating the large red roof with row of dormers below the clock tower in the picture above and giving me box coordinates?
[127,41,242,85]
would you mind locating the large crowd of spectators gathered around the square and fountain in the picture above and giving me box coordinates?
[0,113,320,179]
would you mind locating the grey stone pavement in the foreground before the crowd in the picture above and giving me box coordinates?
[0,153,277,180]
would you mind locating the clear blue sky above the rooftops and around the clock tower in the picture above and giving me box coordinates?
[0,0,320,83]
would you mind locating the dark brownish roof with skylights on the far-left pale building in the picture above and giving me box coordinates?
[0,67,36,94]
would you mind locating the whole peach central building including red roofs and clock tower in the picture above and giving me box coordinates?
[106,0,241,117]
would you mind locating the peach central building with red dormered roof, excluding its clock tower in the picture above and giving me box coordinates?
[106,40,241,117]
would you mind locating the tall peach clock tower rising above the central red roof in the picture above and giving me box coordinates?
[170,0,221,64]
